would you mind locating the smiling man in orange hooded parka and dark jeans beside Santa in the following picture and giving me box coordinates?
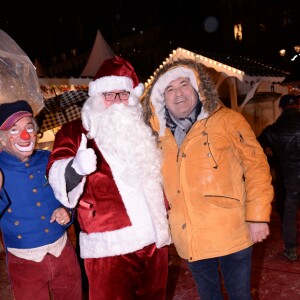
[141,59,273,300]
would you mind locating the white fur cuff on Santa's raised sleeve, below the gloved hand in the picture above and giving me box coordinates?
[49,157,86,208]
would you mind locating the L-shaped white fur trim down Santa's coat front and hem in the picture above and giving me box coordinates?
[80,145,155,258]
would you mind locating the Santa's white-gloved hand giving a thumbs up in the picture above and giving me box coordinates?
[72,134,97,175]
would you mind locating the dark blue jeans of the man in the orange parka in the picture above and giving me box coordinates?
[188,247,252,300]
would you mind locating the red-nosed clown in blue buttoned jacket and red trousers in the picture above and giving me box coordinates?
[0,100,82,300]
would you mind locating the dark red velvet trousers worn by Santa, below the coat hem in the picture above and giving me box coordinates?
[84,244,168,300]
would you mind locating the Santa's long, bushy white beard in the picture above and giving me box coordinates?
[91,103,161,185]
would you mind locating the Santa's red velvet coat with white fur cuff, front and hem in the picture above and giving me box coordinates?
[48,120,171,258]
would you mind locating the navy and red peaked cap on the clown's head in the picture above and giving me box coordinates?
[0,100,33,130]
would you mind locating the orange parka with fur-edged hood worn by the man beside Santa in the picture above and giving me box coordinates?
[142,58,273,261]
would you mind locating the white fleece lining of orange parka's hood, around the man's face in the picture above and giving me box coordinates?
[150,66,199,136]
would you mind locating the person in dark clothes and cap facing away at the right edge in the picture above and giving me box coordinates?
[258,94,300,261]
